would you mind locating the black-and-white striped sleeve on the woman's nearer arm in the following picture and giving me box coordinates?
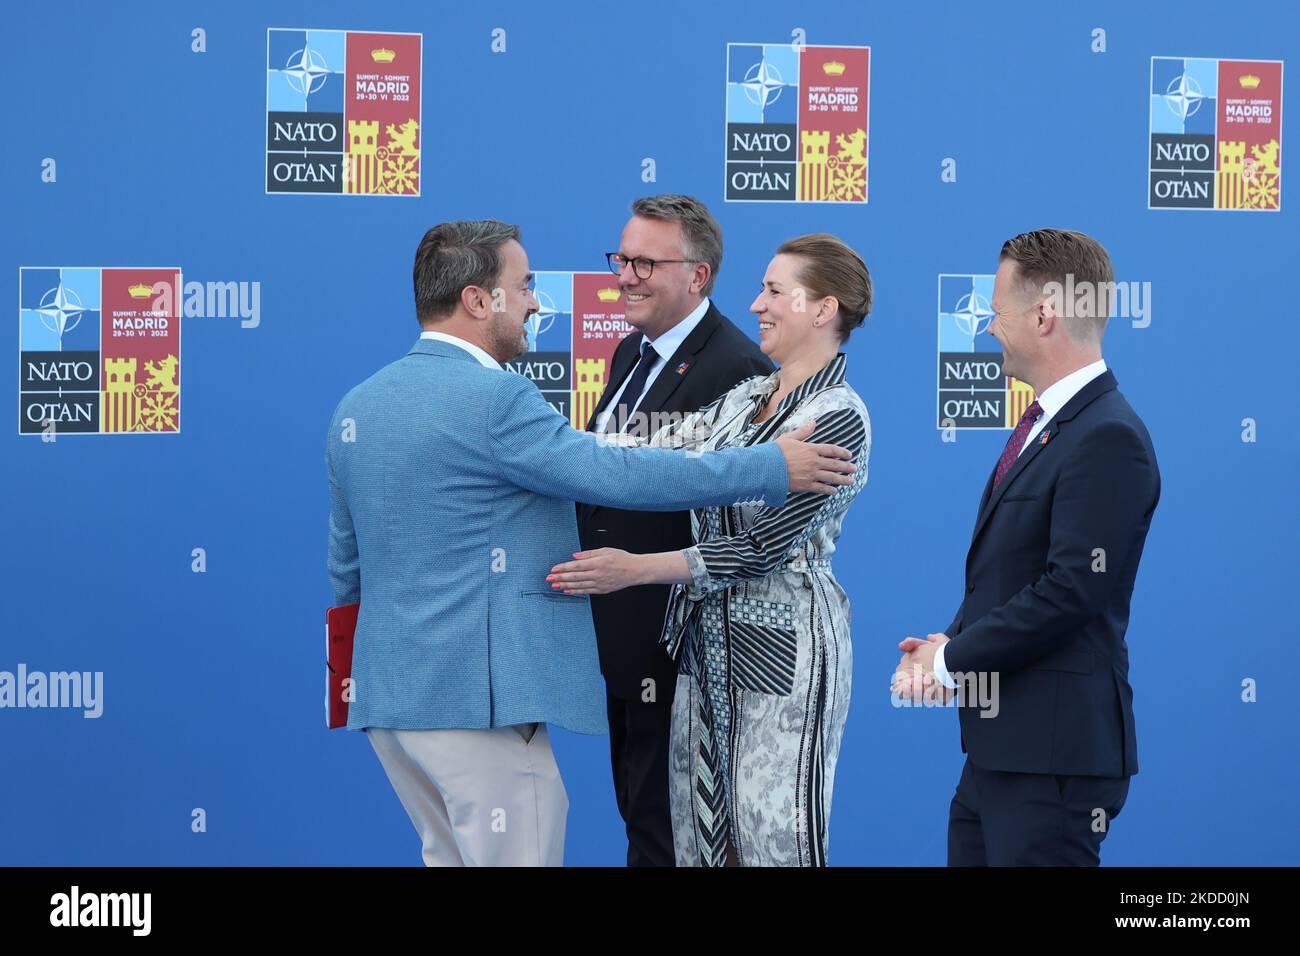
[683,408,871,600]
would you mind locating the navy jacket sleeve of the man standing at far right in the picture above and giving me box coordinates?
[944,421,1157,674]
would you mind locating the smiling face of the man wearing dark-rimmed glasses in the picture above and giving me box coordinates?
[618,216,709,339]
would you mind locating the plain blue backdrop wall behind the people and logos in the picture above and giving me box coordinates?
[0,0,1300,865]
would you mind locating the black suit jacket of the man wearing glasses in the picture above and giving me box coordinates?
[577,302,774,702]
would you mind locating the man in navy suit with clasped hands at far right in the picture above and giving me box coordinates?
[894,229,1160,866]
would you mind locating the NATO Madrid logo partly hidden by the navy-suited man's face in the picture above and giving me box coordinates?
[936,274,1034,428]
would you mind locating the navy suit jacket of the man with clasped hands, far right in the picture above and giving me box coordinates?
[944,371,1160,777]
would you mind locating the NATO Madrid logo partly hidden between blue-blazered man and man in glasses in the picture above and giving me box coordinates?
[506,272,633,429]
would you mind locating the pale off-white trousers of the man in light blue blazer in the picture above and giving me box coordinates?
[367,723,568,866]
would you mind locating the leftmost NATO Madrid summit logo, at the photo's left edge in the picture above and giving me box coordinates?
[18,268,181,436]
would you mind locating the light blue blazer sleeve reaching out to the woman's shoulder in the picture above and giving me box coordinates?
[488,375,789,511]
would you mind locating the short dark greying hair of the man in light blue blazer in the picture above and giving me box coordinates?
[413,219,519,321]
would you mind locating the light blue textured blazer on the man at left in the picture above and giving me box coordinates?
[325,339,788,734]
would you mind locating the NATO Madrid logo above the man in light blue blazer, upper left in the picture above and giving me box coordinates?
[267,29,423,196]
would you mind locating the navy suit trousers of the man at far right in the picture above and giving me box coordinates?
[948,756,1130,866]
